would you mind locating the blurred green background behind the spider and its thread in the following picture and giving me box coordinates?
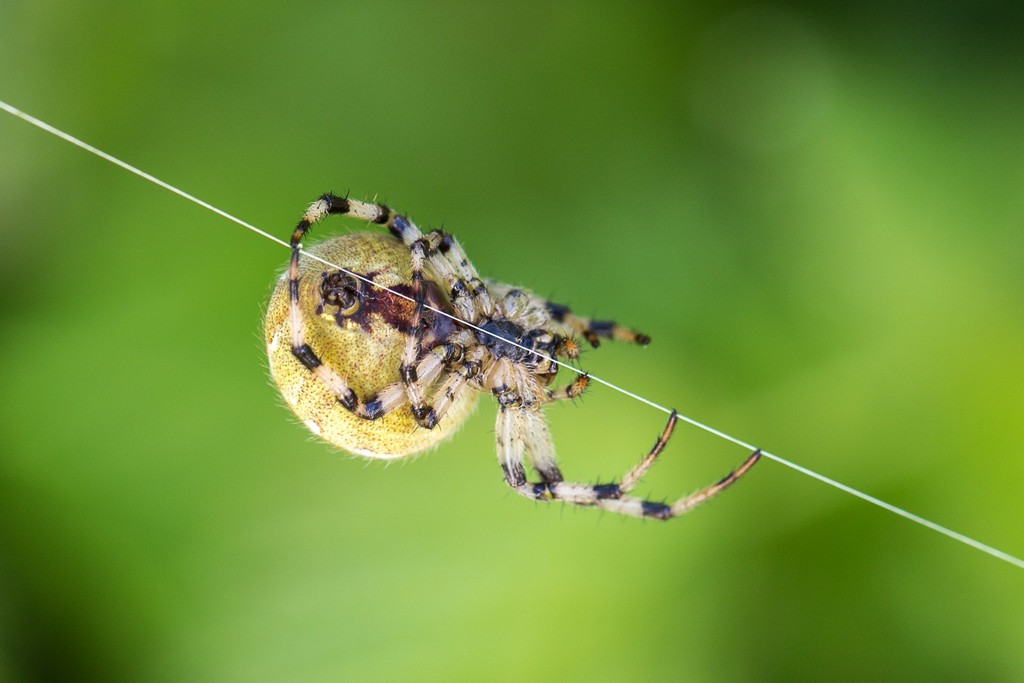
[0,0,1024,682]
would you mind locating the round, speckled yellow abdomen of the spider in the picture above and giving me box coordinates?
[264,232,478,458]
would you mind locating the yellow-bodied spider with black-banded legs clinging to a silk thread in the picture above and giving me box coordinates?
[264,194,761,519]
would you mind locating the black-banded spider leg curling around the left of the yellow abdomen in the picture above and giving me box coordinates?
[288,194,422,420]
